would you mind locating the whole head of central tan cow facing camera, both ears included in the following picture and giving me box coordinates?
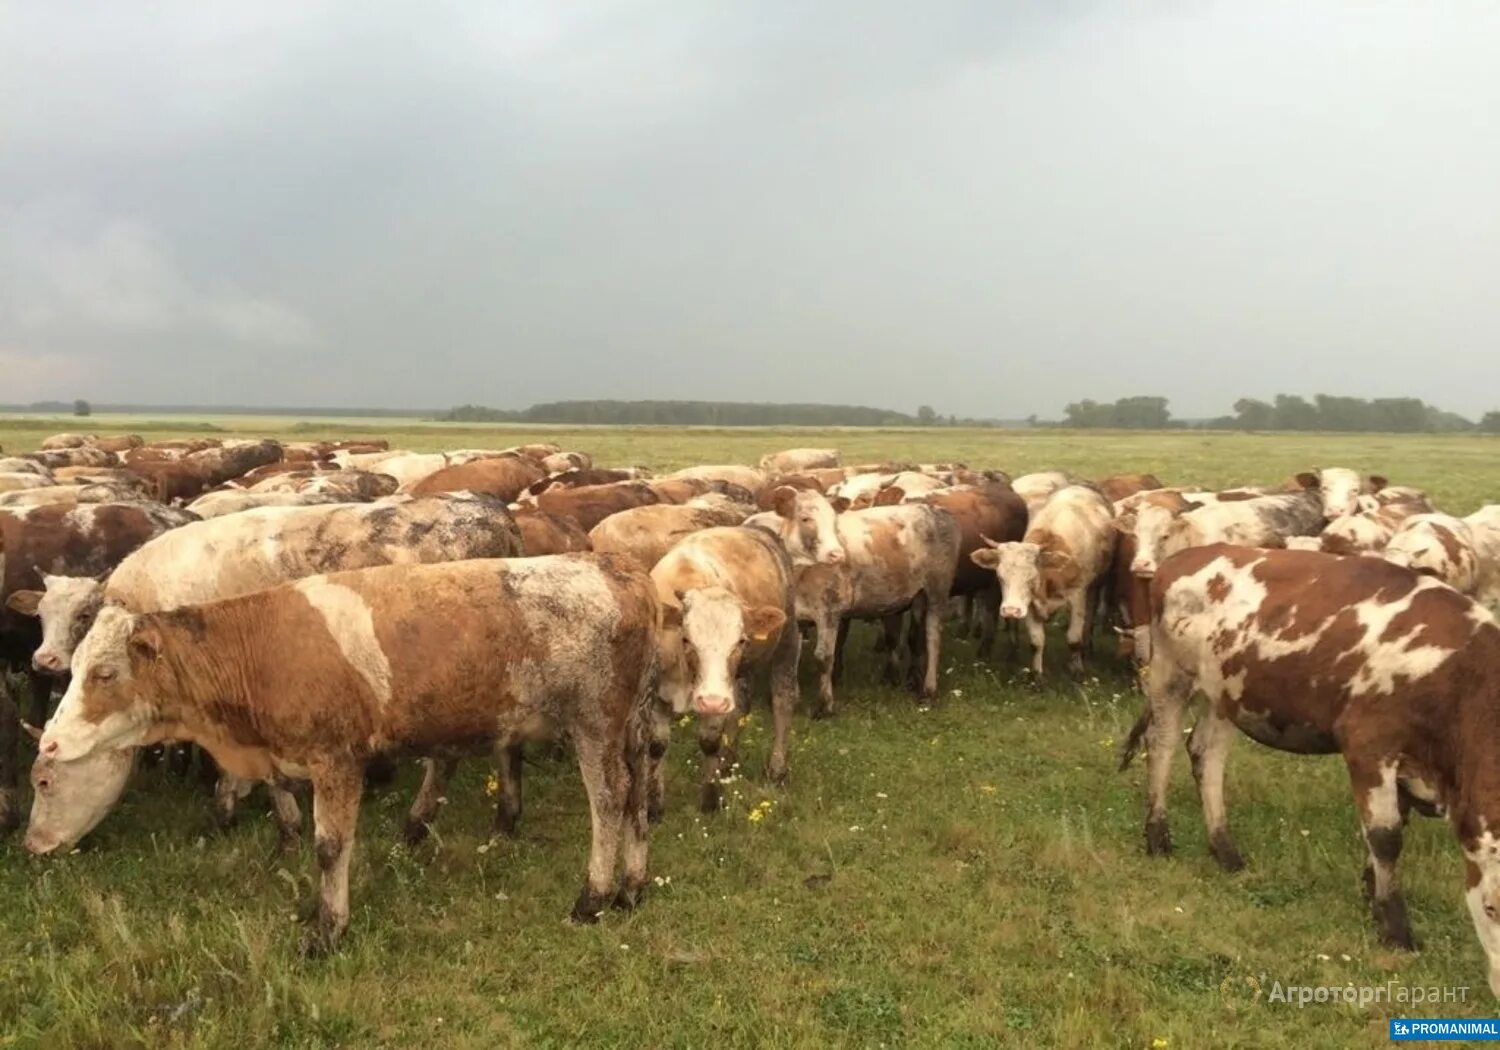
[662,587,786,717]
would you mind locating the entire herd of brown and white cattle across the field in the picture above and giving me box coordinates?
[0,435,1500,995]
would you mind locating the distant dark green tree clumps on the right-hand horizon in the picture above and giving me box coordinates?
[1044,395,1500,434]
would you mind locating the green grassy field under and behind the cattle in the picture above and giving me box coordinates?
[0,420,1500,1049]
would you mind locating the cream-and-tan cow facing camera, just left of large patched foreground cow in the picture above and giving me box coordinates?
[969,485,1115,678]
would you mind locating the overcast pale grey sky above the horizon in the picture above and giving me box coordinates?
[0,0,1500,419]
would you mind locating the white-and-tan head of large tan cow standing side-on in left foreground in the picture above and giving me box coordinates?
[38,606,161,762]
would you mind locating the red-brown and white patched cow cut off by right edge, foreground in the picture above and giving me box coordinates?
[1125,545,1500,995]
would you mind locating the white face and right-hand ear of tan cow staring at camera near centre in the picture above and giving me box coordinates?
[683,587,786,716]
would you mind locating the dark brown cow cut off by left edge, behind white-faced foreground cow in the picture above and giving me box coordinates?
[0,503,194,830]
